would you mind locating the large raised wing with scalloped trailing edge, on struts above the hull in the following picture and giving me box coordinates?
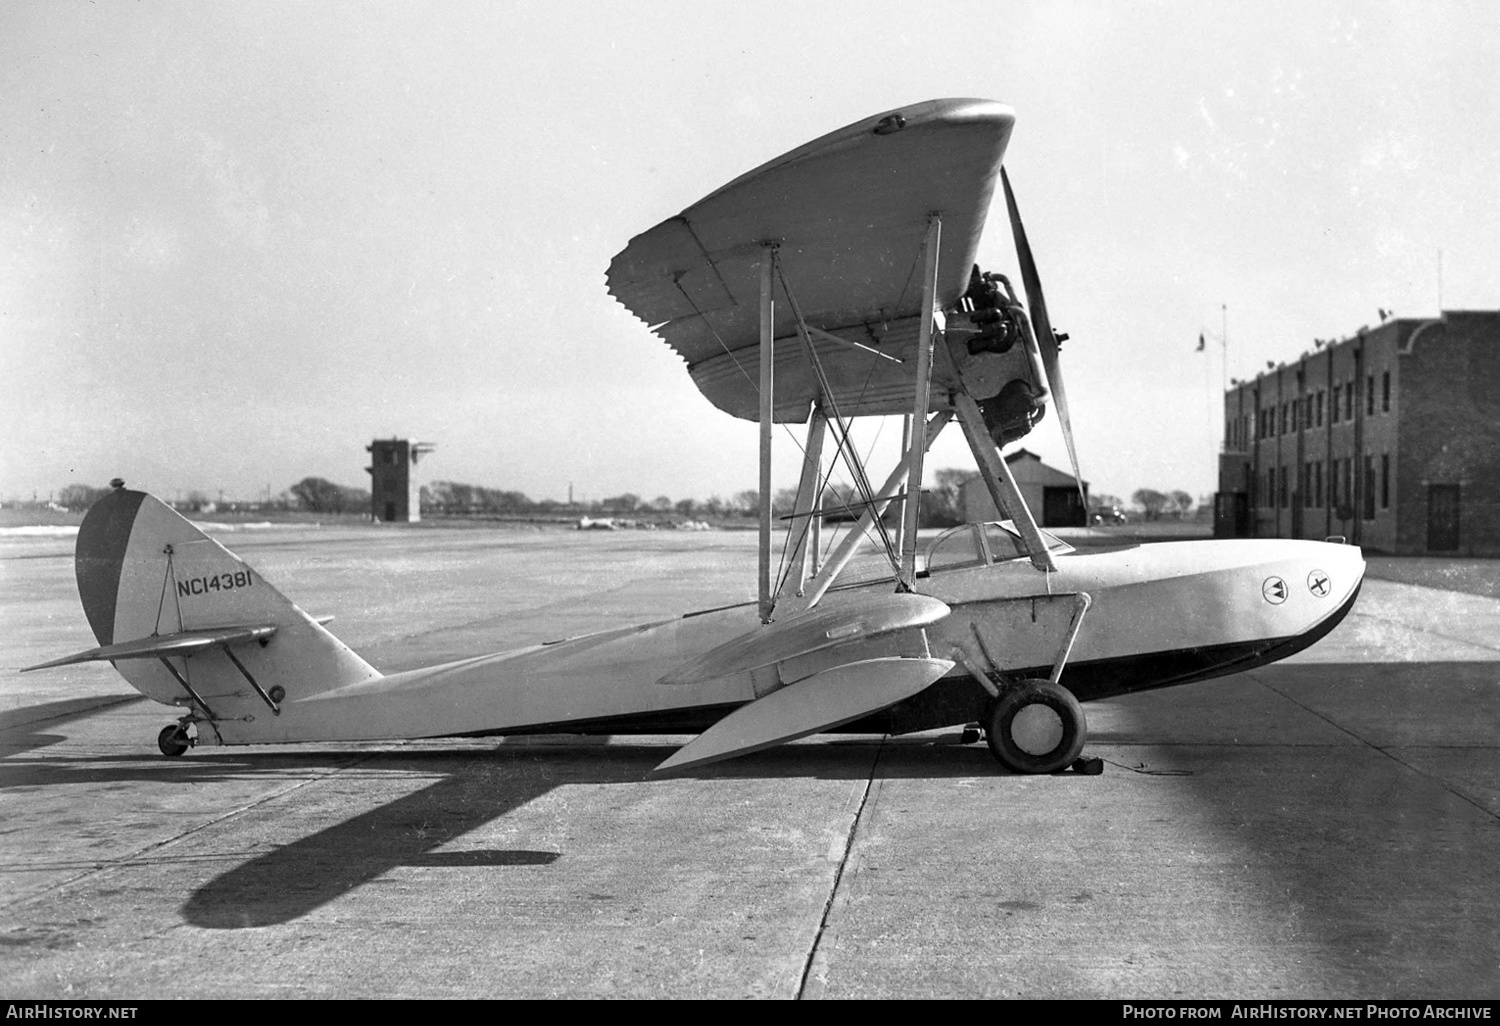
[608,99,1016,422]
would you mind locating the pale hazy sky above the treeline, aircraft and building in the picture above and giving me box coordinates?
[0,0,1500,498]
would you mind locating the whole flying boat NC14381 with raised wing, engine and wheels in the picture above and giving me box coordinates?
[23,99,1364,774]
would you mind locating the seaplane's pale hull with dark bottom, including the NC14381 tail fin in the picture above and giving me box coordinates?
[54,489,1364,744]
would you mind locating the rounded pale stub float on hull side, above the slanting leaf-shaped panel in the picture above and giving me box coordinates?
[657,593,948,686]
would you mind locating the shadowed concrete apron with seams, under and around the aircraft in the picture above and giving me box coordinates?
[0,531,1500,998]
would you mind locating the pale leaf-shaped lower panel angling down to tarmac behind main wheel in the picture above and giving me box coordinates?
[651,657,953,777]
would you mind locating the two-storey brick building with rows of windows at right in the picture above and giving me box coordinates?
[1215,311,1500,555]
